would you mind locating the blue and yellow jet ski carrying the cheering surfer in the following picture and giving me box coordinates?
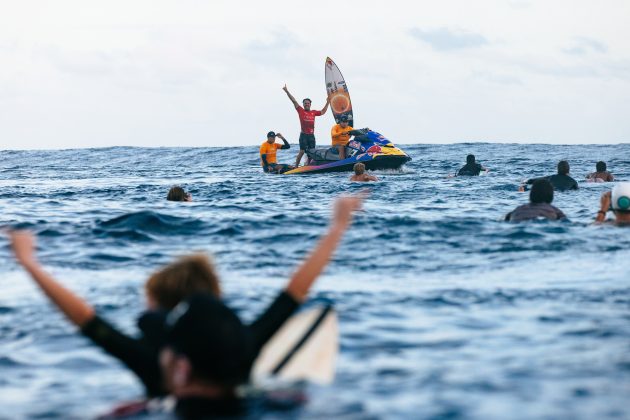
[284,128,411,175]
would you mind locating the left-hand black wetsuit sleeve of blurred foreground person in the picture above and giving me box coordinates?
[81,316,165,396]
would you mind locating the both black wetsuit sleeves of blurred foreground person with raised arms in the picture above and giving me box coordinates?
[81,292,299,396]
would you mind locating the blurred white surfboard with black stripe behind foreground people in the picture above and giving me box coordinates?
[252,306,339,385]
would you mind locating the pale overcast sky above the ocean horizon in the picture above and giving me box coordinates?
[0,0,630,149]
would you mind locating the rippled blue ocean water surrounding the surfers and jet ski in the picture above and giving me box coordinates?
[0,143,630,419]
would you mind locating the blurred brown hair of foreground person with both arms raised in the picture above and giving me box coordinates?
[145,254,221,310]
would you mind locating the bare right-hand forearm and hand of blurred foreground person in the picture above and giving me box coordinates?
[286,196,363,302]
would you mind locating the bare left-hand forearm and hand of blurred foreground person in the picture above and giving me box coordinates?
[10,231,94,327]
